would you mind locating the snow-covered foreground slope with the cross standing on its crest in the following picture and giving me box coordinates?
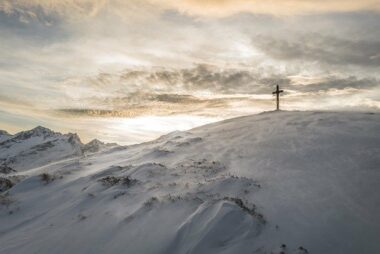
[0,112,380,254]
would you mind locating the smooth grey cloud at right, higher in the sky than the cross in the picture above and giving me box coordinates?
[253,34,380,67]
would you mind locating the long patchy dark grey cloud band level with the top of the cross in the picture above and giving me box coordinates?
[61,64,379,98]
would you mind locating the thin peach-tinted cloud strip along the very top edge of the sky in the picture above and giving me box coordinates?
[0,0,380,21]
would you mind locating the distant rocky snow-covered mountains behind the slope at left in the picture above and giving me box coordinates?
[0,126,117,171]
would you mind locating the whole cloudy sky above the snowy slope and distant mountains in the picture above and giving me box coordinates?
[0,0,380,144]
